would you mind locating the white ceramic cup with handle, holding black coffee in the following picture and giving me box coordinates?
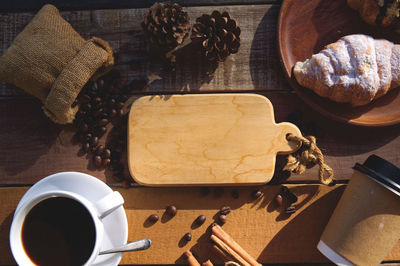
[10,189,124,265]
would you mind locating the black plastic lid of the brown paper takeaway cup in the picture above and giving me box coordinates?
[353,154,400,196]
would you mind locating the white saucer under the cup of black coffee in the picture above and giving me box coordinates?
[15,172,128,266]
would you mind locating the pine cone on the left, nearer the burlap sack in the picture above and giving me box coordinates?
[142,2,190,50]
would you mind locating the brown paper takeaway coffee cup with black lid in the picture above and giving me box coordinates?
[317,155,400,265]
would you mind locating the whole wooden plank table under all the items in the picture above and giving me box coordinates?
[0,0,400,265]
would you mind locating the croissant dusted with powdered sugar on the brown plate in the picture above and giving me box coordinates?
[293,34,400,106]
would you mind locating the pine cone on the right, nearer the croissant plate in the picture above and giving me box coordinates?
[190,11,240,61]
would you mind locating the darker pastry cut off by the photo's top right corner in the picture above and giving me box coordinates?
[347,0,400,31]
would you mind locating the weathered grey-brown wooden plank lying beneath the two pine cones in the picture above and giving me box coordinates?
[0,5,290,96]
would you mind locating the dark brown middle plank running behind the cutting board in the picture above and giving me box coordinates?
[0,92,400,184]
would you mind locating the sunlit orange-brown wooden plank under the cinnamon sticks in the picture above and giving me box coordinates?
[0,185,400,265]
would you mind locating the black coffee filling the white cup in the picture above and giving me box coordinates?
[22,197,96,265]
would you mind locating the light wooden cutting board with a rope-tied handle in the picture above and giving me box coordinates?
[128,94,301,186]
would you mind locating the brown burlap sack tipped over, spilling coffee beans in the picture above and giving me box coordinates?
[0,5,114,124]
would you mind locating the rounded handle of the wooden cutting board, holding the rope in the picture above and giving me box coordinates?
[274,122,302,154]
